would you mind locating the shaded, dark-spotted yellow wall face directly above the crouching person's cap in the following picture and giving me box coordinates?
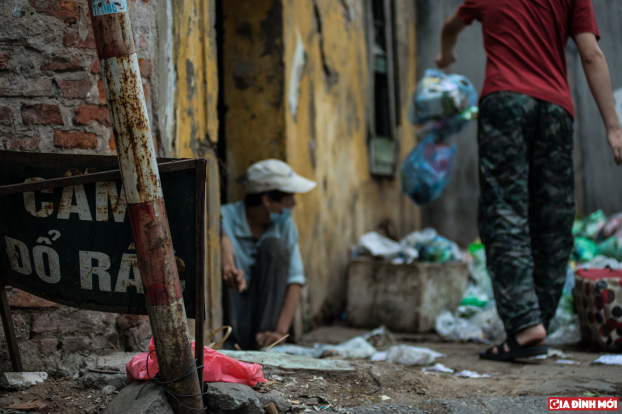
[222,0,285,200]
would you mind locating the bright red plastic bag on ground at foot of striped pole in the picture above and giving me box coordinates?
[125,338,267,387]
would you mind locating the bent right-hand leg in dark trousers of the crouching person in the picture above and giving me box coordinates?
[251,238,290,340]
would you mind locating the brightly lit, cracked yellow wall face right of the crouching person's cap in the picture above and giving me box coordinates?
[283,0,420,320]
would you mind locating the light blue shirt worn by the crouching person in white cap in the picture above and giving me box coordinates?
[220,201,306,285]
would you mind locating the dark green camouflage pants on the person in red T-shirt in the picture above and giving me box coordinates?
[478,92,575,335]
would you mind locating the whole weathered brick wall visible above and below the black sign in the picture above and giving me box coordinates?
[0,0,161,375]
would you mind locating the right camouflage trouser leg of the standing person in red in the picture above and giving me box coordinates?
[529,102,575,329]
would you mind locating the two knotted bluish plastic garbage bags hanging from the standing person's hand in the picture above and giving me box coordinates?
[401,69,478,206]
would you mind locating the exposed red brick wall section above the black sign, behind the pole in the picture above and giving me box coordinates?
[0,0,159,155]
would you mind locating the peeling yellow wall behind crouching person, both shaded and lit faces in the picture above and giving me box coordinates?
[223,0,420,322]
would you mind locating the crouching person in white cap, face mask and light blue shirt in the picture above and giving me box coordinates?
[221,159,317,350]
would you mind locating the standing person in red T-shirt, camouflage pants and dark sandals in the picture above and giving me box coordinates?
[436,0,622,360]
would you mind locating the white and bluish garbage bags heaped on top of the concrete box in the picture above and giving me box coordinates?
[352,229,464,264]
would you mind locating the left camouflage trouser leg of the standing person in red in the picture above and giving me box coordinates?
[478,92,541,338]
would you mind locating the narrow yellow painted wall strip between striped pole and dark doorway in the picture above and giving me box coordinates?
[173,0,223,332]
